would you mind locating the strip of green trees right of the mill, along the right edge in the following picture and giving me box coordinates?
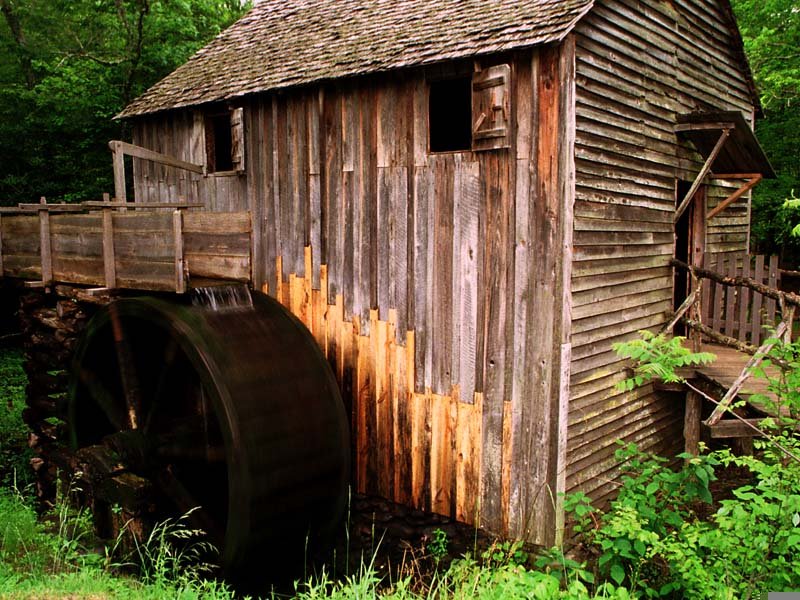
[732,0,800,268]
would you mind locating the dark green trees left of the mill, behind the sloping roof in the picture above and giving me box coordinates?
[0,0,251,205]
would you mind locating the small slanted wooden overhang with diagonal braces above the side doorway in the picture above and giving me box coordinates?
[674,111,775,222]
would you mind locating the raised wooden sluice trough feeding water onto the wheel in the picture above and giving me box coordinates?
[0,200,252,293]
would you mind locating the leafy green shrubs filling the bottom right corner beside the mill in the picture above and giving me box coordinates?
[576,336,800,598]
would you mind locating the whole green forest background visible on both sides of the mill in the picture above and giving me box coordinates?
[0,0,800,262]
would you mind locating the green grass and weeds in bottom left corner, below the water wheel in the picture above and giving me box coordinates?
[0,488,234,600]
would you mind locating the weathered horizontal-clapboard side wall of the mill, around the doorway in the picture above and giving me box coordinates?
[566,0,752,508]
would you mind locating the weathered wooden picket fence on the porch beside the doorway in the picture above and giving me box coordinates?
[700,253,780,346]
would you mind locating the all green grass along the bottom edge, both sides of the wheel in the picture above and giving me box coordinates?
[0,349,629,600]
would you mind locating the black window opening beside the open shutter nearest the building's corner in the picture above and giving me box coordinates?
[428,77,472,152]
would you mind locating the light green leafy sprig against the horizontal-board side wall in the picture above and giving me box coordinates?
[613,331,716,391]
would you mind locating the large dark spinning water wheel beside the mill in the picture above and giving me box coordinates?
[68,293,349,579]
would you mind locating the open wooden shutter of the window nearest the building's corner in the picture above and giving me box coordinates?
[472,65,511,151]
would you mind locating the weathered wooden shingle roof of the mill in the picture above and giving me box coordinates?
[119,0,594,117]
